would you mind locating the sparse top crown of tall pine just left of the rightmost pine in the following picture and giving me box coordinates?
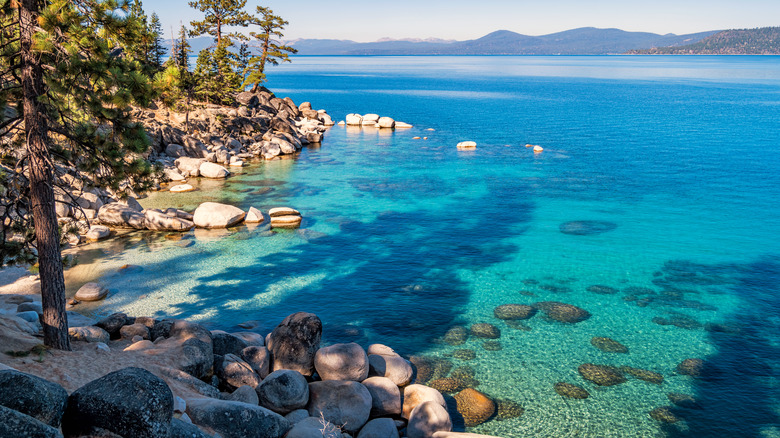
[189,0,252,47]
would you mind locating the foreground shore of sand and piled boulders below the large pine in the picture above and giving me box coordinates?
[0,276,500,438]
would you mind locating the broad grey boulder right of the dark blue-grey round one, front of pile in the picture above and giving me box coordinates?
[306,380,371,433]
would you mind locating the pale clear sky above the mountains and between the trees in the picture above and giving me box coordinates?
[144,0,780,41]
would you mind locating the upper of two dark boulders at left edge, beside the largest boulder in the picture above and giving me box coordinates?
[0,370,68,427]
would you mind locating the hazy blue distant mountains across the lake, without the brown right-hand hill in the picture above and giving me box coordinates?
[288,27,718,55]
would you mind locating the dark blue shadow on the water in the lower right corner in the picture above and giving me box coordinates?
[666,256,780,438]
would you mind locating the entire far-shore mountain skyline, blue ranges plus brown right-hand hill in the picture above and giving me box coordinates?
[168,27,780,56]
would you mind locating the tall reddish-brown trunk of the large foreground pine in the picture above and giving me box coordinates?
[19,0,70,350]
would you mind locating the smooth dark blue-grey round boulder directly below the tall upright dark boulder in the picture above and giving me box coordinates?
[256,370,309,415]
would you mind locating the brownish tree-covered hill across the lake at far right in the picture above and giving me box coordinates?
[629,27,780,55]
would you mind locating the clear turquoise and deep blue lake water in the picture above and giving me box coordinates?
[69,57,780,437]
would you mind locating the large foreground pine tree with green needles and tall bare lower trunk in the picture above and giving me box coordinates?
[0,0,158,350]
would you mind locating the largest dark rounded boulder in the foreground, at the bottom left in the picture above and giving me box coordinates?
[62,367,173,438]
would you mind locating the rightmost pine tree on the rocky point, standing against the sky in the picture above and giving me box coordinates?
[244,6,298,93]
